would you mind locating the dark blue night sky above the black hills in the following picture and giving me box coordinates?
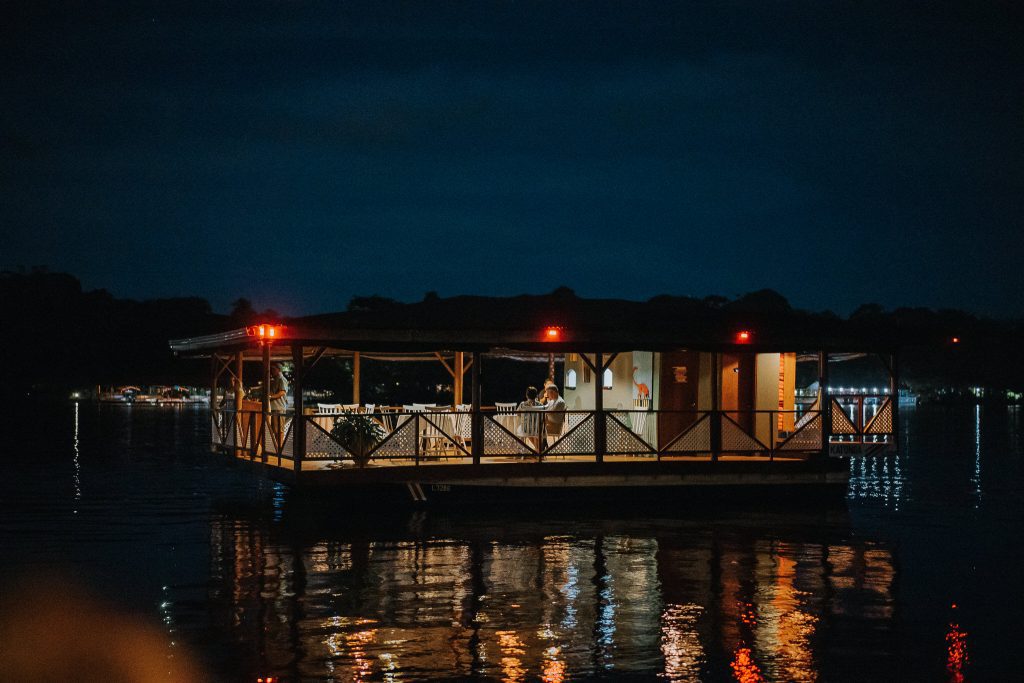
[0,0,1024,315]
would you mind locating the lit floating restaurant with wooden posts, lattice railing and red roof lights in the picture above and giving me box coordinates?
[170,292,899,502]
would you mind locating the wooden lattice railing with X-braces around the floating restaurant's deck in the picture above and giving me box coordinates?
[205,398,893,469]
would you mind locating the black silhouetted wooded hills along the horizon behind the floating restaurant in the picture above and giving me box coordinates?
[0,270,1024,395]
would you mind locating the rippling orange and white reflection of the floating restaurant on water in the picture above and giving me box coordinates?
[193,513,895,681]
